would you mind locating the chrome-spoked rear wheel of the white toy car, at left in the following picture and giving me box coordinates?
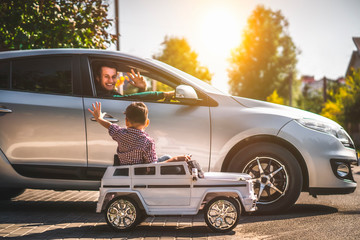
[105,197,141,231]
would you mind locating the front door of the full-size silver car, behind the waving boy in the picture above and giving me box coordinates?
[84,58,210,169]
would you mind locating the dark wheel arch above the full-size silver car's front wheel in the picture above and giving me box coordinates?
[221,135,309,191]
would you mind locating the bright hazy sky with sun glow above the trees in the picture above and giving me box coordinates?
[108,0,360,92]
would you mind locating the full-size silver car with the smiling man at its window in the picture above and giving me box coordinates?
[0,49,357,211]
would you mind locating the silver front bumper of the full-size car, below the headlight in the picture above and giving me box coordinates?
[278,121,359,194]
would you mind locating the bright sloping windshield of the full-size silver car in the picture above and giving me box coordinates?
[147,59,229,95]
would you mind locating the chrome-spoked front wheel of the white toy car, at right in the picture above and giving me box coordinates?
[204,197,241,232]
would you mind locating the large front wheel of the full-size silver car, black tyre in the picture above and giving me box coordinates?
[227,143,303,212]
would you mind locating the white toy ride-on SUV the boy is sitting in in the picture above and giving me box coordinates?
[96,161,256,232]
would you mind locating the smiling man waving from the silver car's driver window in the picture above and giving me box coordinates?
[95,63,174,100]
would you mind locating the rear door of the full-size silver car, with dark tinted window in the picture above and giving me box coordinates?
[0,56,87,179]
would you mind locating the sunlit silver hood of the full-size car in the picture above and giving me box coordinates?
[232,97,340,127]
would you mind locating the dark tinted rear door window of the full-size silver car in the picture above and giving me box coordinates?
[12,57,72,95]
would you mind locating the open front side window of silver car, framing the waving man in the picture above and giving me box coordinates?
[91,59,176,102]
